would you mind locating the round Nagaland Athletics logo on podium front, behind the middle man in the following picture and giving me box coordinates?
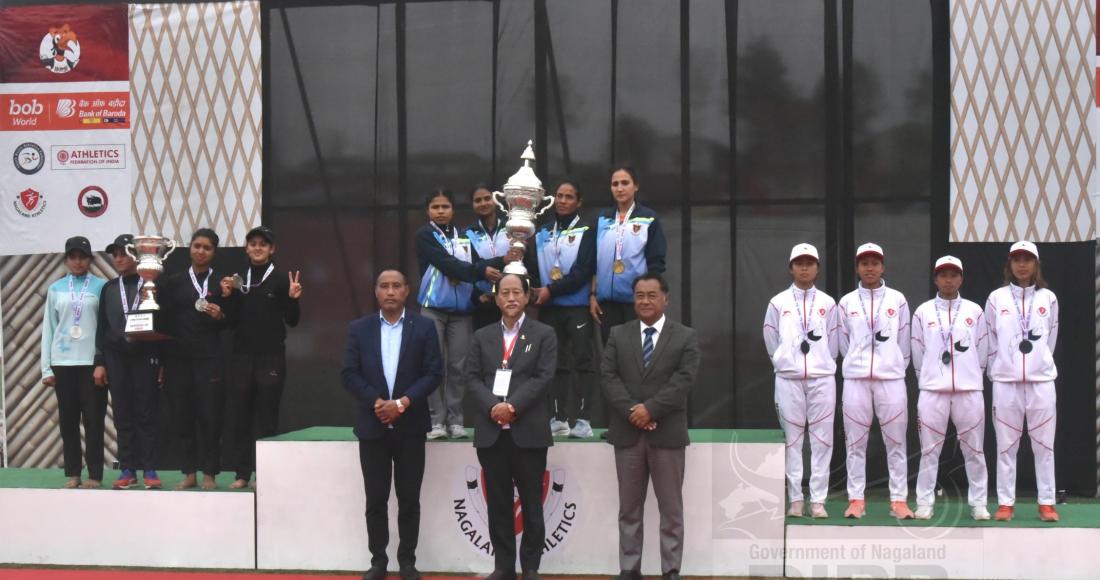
[451,466,581,558]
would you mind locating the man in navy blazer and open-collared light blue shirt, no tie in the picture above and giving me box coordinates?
[342,270,443,580]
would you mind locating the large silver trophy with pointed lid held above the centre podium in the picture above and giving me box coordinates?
[493,141,553,276]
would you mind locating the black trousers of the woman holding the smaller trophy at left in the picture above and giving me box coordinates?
[103,351,161,470]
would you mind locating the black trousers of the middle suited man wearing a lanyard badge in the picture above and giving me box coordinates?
[477,429,547,574]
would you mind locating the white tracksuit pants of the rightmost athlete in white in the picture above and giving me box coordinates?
[993,381,1057,505]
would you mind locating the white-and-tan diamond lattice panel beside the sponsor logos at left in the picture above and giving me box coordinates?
[130,2,263,245]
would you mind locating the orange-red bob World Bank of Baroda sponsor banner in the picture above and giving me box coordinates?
[0,91,130,131]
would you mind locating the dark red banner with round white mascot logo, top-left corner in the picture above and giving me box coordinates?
[0,3,130,83]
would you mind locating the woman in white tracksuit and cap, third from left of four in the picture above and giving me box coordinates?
[912,255,989,519]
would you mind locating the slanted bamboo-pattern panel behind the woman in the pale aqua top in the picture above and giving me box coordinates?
[0,254,118,468]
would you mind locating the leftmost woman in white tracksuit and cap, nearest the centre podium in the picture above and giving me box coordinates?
[763,243,838,517]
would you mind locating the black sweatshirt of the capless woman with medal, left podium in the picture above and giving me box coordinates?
[157,269,230,359]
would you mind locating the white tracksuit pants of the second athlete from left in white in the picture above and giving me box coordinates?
[842,379,909,502]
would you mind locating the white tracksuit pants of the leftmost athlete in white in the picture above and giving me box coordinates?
[776,376,836,503]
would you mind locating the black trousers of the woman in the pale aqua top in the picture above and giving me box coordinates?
[53,364,107,481]
